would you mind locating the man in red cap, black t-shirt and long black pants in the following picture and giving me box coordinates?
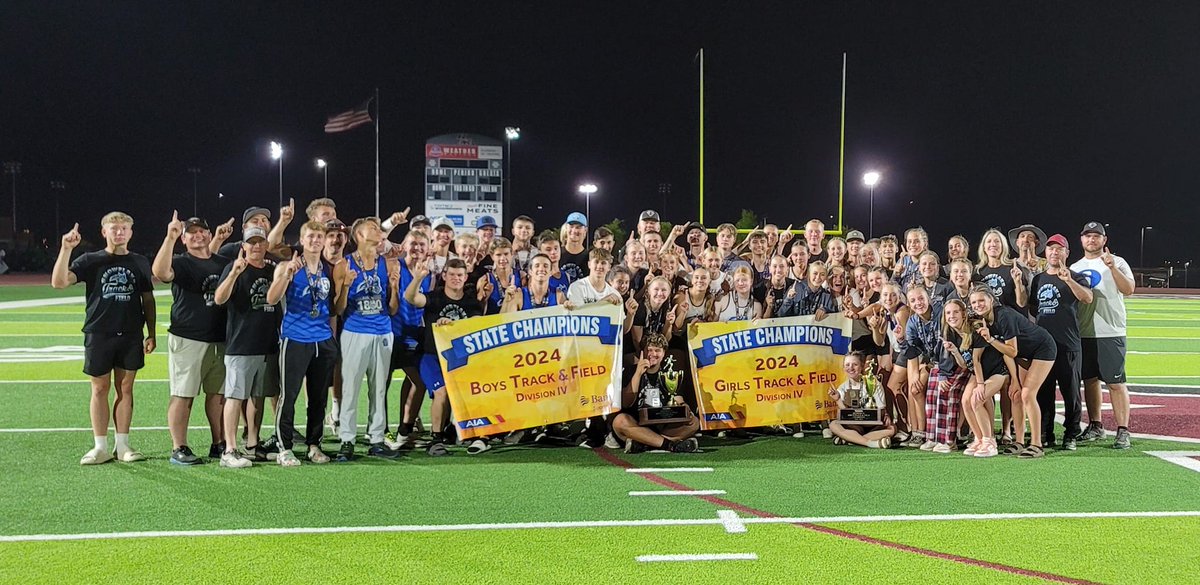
[1030,234,1092,451]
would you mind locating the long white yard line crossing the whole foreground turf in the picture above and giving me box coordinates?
[0,509,1200,542]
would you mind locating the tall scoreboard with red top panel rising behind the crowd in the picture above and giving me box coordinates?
[425,134,504,233]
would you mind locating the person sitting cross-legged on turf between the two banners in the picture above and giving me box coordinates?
[612,333,700,453]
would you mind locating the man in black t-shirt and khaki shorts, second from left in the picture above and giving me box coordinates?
[152,211,229,465]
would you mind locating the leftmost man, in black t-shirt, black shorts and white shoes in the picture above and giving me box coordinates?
[50,211,157,465]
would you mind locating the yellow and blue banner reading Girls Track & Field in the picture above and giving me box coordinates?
[688,315,850,430]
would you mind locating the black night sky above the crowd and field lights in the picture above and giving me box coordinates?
[0,0,1200,265]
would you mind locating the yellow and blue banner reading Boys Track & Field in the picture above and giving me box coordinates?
[433,302,625,438]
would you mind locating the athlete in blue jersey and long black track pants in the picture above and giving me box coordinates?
[266,222,337,466]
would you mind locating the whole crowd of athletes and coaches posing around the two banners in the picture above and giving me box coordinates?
[52,191,1133,468]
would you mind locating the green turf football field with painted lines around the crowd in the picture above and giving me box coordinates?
[0,287,1200,584]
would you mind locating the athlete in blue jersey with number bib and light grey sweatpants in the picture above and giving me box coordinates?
[334,217,400,462]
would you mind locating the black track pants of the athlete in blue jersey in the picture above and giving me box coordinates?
[277,338,337,450]
